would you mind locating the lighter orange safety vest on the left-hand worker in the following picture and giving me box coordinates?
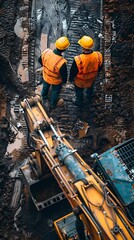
[41,48,67,85]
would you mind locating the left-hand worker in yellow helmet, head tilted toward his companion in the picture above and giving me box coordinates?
[39,36,70,108]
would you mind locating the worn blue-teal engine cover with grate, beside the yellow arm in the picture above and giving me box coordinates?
[95,138,134,221]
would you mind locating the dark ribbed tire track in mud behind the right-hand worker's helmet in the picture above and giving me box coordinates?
[65,1,100,68]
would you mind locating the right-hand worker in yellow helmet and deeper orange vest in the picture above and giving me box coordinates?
[69,36,102,108]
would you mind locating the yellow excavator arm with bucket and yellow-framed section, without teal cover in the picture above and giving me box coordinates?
[21,96,134,240]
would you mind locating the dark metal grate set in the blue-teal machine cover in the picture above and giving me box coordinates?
[116,139,134,179]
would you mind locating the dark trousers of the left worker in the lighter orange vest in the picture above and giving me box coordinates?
[41,81,62,108]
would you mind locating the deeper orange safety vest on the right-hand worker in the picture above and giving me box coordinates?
[74,52,102,88]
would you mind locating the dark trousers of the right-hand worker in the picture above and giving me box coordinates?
[75,85,94,107]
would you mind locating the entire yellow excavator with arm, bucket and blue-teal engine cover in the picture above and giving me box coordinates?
[21,96,134,240]
